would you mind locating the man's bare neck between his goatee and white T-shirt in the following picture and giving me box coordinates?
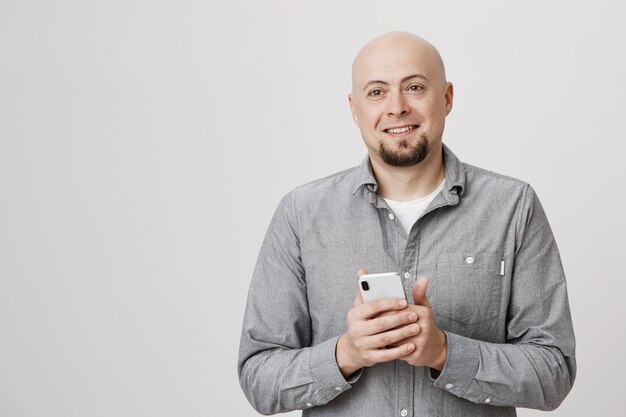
[370,147,445,201]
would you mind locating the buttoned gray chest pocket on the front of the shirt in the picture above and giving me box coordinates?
[433,252,502,324]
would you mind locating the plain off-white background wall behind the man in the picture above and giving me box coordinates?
[0,0,626,417]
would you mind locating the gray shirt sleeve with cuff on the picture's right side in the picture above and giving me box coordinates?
[434,186,576,410]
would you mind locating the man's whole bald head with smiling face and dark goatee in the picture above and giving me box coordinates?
[349,32,453,167]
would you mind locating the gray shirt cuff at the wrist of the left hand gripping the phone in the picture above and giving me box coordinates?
[309,336,362,404]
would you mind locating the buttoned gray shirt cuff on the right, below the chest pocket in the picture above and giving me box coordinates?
[431,332,480,397]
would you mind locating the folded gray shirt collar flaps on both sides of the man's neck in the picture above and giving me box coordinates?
[352,144,465,200]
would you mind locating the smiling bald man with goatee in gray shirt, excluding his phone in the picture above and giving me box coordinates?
[238,32,576,417]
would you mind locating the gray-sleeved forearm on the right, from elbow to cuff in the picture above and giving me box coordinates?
[435,333,576,410]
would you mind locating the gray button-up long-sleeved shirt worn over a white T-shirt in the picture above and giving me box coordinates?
[238,145,576,417]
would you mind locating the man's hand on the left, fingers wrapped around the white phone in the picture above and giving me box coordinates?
[336,269,419,378]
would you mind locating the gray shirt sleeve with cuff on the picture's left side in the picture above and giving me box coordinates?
[238,192,360,414]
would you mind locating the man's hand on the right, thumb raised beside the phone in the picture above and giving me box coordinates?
[397,277,448,371]
